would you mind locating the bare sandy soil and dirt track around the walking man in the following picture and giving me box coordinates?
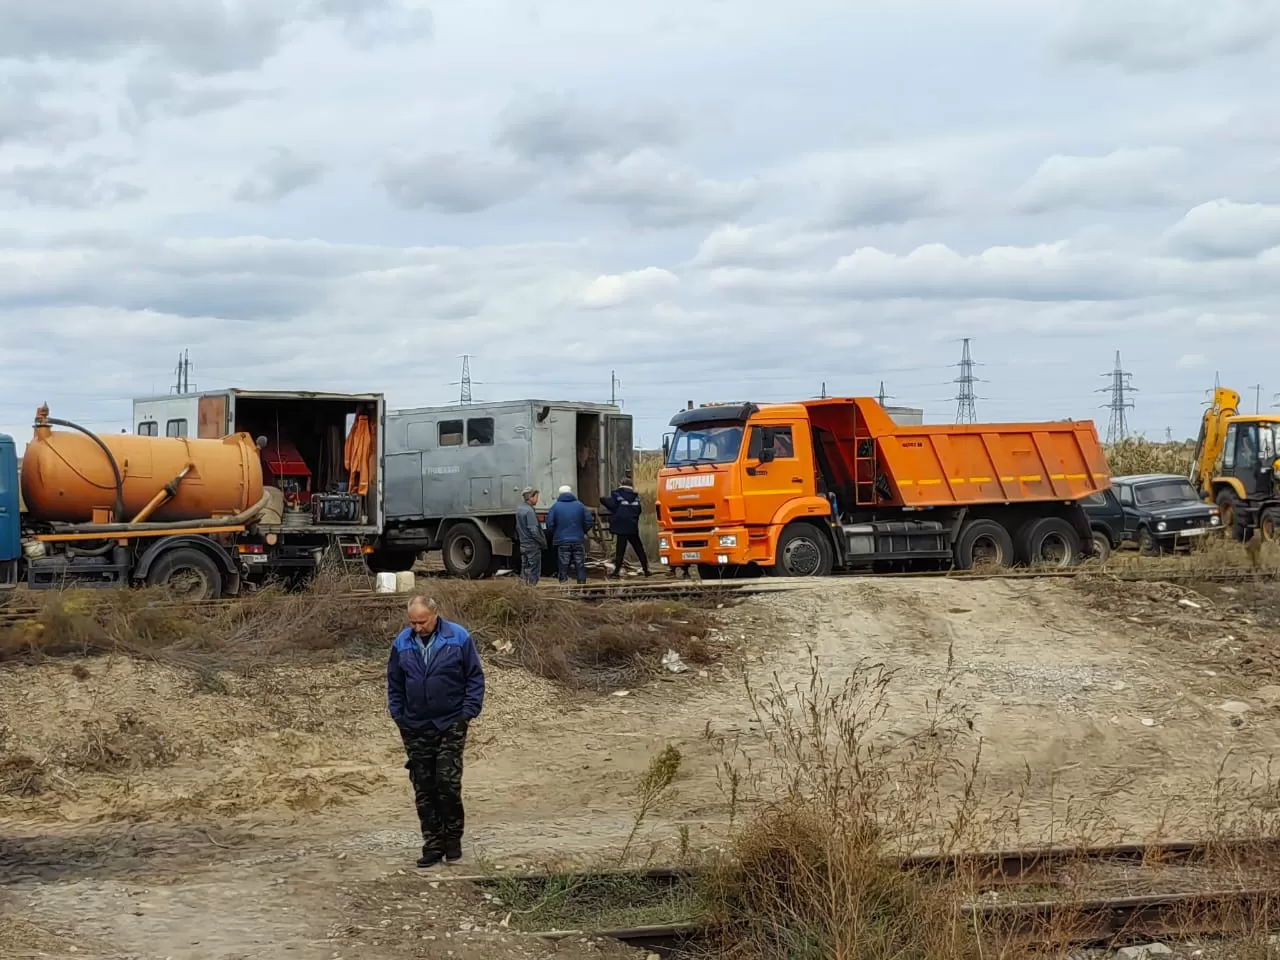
[0,579,1280,960]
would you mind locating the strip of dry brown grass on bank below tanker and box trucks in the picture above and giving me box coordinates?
[0,570,716,692]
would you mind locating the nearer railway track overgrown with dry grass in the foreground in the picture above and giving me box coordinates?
[478,837,1280,956]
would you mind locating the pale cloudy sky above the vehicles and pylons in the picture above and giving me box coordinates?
[0,0,1280,453]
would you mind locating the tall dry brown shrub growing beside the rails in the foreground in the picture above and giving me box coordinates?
[707,658,980,960]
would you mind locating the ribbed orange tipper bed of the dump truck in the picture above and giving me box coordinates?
[805,397,1111,507]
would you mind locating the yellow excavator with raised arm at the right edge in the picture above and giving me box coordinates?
[1189,387,1280,540]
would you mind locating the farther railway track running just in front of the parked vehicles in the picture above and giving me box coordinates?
[0,567,1280,625]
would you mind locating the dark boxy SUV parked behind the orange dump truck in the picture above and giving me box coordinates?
[1111,474,1222,554]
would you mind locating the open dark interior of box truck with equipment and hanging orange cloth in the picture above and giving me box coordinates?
[232,396,376,527]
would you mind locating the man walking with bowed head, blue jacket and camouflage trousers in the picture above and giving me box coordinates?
[387,596,484,867]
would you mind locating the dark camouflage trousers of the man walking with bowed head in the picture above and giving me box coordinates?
[401,721,467,856]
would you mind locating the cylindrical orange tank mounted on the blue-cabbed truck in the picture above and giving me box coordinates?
[22,422,262,524]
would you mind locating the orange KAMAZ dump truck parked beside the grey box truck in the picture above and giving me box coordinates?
[658,397,1111,577]
